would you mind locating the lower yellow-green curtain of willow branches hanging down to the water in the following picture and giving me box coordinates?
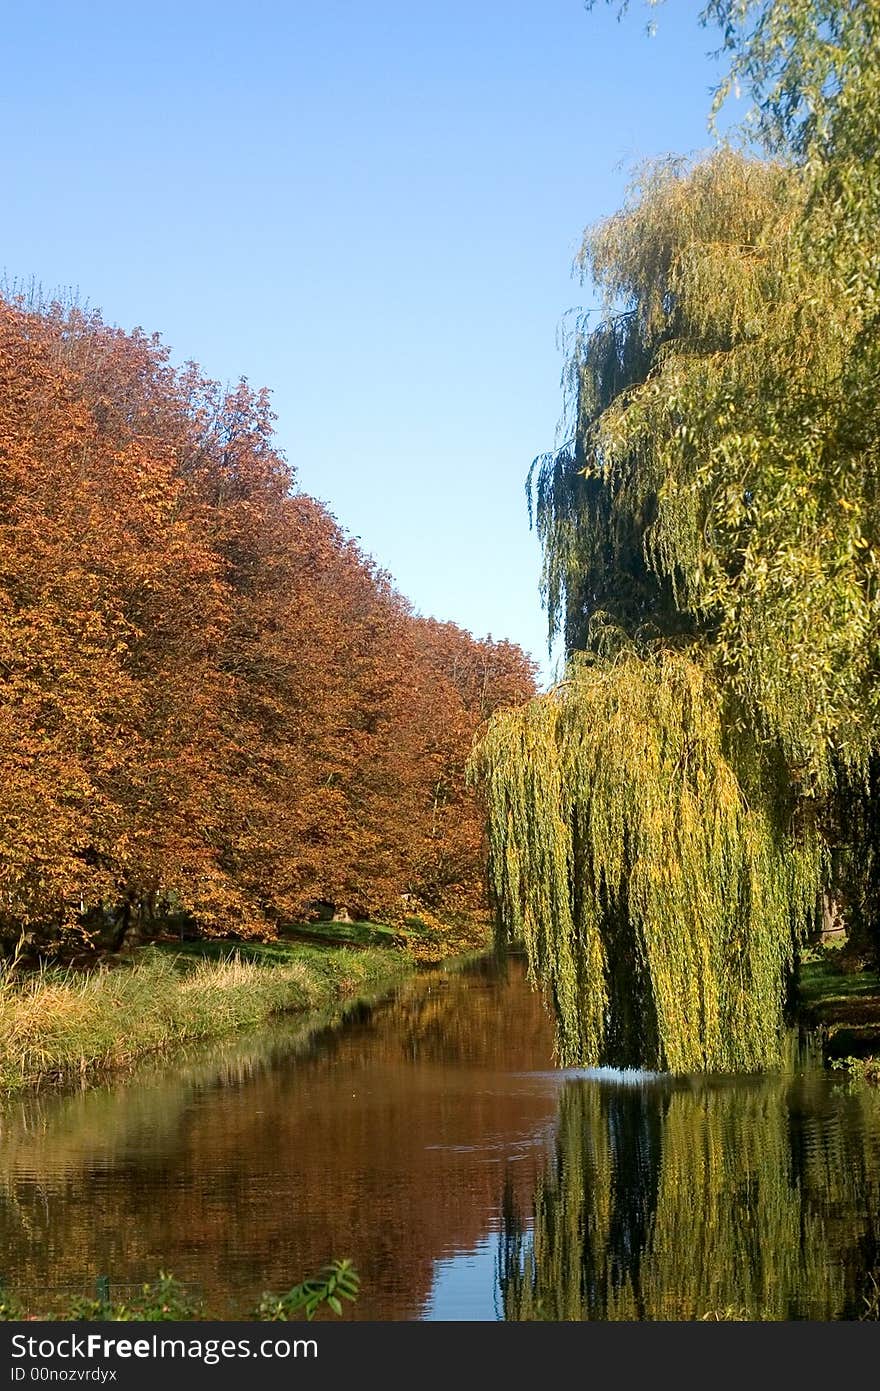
[471,650,823,1072]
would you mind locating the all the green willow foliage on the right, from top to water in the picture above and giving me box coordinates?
[474,0,880,1071]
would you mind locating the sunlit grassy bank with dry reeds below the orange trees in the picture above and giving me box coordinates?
[0,943,416,1092]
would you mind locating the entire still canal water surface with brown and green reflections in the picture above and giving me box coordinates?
[0,961,880,1320]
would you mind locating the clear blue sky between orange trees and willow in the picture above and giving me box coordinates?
[0,0,734,684]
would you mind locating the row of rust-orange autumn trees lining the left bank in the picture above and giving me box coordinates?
[0,302,534,939]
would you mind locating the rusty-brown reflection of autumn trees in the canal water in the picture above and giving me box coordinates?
[0,964,556,1319]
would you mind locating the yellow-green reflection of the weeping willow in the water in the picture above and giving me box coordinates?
[499,1077,880,1320]
